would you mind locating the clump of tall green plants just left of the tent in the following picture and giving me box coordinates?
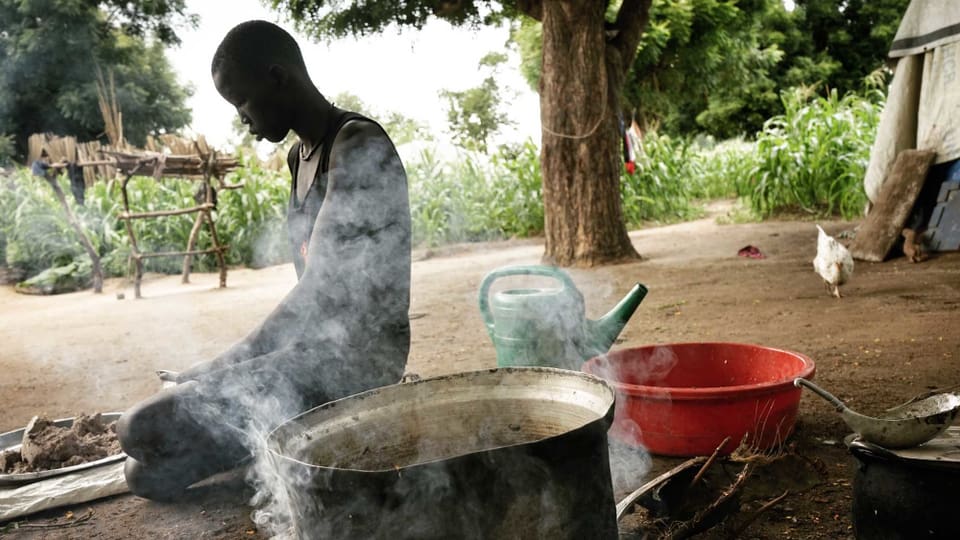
[738,89,882,218]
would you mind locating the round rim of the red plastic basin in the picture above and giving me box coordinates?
[583,341,816,401]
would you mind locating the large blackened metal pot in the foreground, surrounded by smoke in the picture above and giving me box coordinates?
[267,367,617,540]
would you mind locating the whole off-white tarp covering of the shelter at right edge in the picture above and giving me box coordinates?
[863,0,960,203]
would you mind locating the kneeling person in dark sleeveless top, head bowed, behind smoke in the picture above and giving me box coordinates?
[118,21,410,499]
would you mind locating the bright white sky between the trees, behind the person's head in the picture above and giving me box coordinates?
[167,0,540,150]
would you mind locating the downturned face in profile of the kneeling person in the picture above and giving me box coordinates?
[213,65,290,142]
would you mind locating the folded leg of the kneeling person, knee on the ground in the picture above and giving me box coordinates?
[117,336,406,500]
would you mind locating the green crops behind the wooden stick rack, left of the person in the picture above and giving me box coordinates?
[0,160,291,282]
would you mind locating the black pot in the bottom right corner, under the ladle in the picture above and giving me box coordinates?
[847,427,960,540]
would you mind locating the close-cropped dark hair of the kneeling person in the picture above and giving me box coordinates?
[210,21,307,78]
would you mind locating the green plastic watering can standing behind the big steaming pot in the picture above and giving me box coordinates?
[480,266,647,370]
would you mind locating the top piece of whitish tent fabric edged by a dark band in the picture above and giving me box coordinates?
[890,0,960,58]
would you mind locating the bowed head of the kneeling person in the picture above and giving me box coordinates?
[210,21,313,142]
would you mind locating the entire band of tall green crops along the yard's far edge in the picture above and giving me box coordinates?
[0,88,883,286]
